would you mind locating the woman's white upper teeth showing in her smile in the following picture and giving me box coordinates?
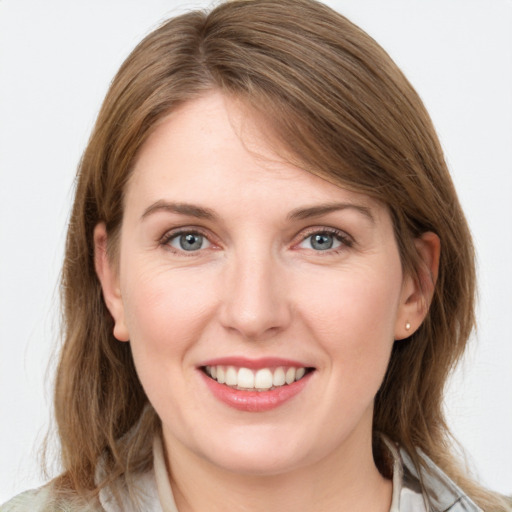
[205,365,306,391]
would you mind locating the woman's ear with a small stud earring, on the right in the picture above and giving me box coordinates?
[395,231,441,340]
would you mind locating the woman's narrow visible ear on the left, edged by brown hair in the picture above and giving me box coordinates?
[94,222,130,341]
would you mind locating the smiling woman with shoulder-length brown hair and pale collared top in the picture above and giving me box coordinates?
[2,0,507,512]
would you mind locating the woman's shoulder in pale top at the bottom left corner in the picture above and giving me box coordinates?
[0,485,103,512]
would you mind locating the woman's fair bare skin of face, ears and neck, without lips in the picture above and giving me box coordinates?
[95,92,439,512]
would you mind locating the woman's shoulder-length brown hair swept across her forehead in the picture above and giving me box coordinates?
[55,0,503,510]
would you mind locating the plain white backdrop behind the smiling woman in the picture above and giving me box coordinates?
[0,0,512,503]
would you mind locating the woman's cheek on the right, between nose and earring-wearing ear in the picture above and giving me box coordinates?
[303,265,401,378]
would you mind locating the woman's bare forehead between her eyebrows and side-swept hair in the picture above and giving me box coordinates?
[126,92,383,220]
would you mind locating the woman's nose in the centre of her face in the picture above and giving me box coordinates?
[220,247,292,341]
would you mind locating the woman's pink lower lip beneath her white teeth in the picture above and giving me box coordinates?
[200,370,313,412]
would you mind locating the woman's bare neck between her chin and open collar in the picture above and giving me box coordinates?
[163,422,392,512]
